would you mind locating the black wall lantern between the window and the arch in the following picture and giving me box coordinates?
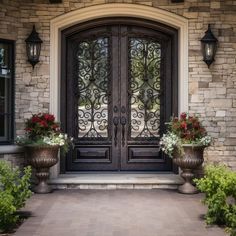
[25,25,43,68]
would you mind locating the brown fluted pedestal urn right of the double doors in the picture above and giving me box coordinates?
[173,144,205,194]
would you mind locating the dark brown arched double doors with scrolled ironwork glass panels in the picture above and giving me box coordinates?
[62,19,177,171]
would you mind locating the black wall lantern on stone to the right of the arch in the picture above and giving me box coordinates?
[201,24,218,68]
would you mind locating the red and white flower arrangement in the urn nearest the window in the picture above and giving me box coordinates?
[16,113,73,153]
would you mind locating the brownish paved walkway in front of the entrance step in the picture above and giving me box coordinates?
[14,189,226,236]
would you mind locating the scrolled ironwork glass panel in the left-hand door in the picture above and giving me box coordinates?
[76,37,110,139]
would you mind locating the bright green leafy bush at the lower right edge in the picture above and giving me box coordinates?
[195,165,236,236]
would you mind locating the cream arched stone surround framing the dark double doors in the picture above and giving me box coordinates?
[50,4,188,176]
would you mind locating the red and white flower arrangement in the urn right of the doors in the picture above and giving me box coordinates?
[160,112,211,157]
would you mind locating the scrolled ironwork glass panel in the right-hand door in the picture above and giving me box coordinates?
[129,37,161,139]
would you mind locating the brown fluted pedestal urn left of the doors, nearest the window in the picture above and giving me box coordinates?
[25,145,59,193]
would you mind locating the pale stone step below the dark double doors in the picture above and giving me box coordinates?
[49,173,183,189]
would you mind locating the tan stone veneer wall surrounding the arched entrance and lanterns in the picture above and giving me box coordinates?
[0,0,236,169]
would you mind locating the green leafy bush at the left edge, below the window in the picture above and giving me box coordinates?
[0,161,31,231]
